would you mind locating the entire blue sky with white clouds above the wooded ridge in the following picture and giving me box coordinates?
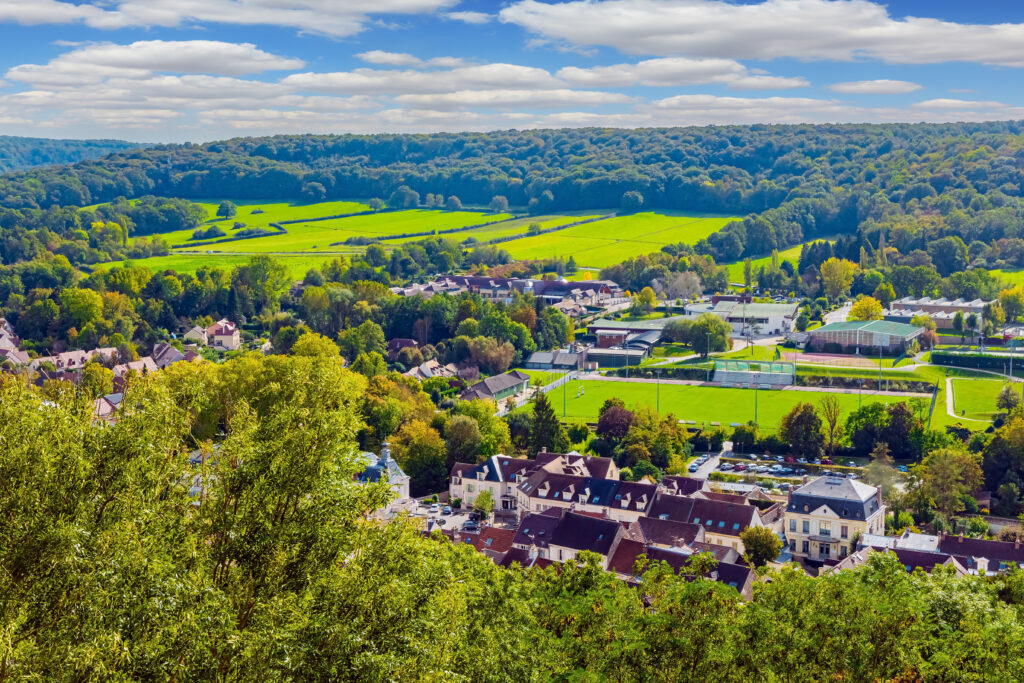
[0,0,1024,141]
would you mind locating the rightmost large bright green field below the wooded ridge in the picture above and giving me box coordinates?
[502,211,735,268]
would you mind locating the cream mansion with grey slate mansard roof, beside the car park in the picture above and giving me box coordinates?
[783,476,886,562]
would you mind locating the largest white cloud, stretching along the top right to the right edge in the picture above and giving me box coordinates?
[499,0,1024,67]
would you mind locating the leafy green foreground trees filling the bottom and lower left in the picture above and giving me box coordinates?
[6,353,1024,682]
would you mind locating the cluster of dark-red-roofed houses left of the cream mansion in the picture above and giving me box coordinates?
[449,452,784,595]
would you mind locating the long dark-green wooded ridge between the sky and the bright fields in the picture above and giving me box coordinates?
[0,122,1024,261]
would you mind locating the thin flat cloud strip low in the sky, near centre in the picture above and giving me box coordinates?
[394,89,633,110]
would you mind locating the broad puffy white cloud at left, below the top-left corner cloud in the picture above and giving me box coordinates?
[5,40,305,87]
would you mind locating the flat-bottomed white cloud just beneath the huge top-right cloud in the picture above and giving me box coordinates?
[557,57,809,90]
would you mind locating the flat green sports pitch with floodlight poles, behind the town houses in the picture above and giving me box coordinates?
[548,380,893,429]
